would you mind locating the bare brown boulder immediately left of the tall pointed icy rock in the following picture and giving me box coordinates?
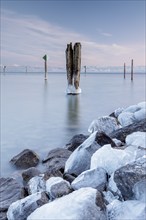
[42,148,72,173]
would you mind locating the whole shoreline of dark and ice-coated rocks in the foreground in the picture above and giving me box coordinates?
[0,102,146,220]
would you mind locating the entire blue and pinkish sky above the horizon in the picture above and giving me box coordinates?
[1,0,146,68]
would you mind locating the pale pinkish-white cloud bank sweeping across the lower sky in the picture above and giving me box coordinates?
[1,10,145,68]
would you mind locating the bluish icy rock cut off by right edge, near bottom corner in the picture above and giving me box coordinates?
[133,179,146,203]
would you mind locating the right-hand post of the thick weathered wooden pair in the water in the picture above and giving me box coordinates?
[73,43,81,89]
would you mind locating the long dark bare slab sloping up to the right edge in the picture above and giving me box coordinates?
[109,119,146,142]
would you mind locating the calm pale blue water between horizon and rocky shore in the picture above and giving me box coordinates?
[1,73,146,176]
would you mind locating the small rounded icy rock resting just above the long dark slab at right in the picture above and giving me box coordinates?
[118,112,135,127]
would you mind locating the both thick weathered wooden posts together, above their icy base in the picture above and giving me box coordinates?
[66,43,81,89]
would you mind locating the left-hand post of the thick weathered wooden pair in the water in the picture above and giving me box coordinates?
[66,43,73,85]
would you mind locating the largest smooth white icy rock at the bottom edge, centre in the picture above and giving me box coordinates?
[27,187,106,220]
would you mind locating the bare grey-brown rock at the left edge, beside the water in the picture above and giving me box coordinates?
[0,178,24,212]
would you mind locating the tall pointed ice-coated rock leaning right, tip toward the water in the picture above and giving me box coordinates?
[65,131,101,175]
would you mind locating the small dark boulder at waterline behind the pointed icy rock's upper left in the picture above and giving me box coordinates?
[65,134,89,151]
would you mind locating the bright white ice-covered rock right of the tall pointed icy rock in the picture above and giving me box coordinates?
[90,144,135,175]
